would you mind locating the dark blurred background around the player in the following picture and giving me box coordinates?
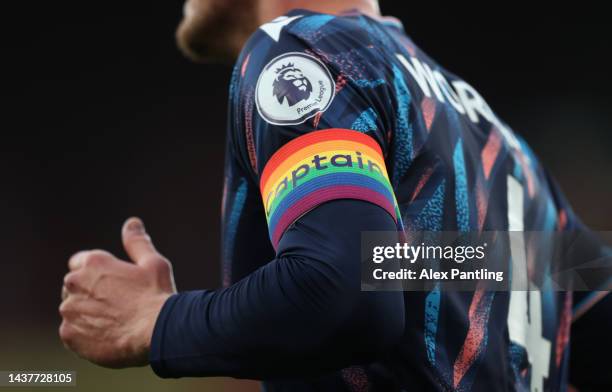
[0,0,612,392]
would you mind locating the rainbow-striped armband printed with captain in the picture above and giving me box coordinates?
[259,129,401,248]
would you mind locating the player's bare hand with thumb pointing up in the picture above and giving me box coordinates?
[59,218,176,368]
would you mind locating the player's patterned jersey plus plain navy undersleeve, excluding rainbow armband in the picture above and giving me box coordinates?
[151,10,612,391]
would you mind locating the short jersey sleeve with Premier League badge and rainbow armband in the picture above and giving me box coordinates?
[230,15,401,248]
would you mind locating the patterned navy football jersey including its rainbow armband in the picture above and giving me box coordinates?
[223,10,608,391]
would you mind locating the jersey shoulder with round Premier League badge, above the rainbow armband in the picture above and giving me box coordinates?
[230,11,390,172]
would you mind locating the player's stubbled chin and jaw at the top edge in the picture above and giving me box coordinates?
[176,0,259,61]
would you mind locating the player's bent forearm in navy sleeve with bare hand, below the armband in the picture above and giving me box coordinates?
[60,200,404,378]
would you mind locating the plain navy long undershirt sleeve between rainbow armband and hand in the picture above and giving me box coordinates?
[150,200,404,379]
